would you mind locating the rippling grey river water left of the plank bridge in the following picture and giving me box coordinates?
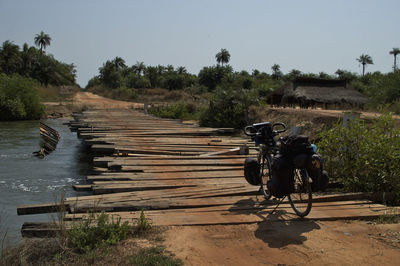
[0,119,91,243]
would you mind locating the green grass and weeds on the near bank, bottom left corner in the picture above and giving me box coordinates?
[0,208,182,265]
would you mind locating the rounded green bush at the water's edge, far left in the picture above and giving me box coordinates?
[0,74,45,120]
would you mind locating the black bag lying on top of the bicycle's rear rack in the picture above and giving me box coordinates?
[279,135,314,159]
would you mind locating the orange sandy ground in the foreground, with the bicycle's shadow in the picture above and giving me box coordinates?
[165,221,400,265]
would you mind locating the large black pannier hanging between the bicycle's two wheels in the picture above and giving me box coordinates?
[267,154,294,198]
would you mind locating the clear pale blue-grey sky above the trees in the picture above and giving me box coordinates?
[0,0,400,87]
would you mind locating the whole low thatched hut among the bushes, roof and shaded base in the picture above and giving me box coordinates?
[267,78,367,108]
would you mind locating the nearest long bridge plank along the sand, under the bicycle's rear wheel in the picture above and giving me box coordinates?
[66,201,391,226]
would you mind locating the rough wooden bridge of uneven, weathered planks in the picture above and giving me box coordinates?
[17,110,396,236]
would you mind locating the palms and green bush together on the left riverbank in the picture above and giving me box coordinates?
[0,31,76,121]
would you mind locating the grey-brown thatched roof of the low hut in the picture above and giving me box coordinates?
[268,78,367,104]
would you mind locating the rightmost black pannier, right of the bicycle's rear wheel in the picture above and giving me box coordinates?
[306,153,329,192]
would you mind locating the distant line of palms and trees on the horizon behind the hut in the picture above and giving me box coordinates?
[86,48,400,96]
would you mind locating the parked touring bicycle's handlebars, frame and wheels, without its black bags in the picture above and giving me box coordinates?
[244,122,312,217]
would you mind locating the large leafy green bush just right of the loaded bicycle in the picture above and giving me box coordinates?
[318,114,400,193]
